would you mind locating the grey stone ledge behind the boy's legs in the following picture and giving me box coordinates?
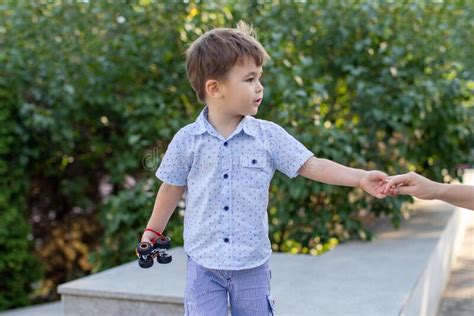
[58,173,474,316]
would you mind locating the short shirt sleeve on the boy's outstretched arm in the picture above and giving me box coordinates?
[270,122,314,178]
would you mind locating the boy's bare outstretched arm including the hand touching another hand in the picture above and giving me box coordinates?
[298,156,387,198]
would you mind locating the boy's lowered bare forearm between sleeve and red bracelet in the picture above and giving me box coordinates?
[147,183,186,232]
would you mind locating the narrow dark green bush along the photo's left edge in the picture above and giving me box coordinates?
[0,99,42,310]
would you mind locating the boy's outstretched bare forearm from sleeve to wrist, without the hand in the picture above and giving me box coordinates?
[299,157,366,187]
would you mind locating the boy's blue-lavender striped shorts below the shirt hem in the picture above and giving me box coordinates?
[184,256,275,316]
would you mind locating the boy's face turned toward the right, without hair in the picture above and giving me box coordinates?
[220,58,263,115]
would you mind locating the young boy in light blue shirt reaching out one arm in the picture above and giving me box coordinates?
[142,22,387,316]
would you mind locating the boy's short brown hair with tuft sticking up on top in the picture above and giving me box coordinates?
[186,21,270,103]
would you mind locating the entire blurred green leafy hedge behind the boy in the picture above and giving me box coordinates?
[0,0,474,310]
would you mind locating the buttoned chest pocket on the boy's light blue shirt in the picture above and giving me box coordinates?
[240,152,270,188]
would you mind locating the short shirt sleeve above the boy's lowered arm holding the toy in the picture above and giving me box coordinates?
[156,130,191,186]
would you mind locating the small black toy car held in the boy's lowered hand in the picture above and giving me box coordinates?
[135,236,172,268]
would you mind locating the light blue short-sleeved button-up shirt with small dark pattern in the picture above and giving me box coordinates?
[156,106,313,270]
